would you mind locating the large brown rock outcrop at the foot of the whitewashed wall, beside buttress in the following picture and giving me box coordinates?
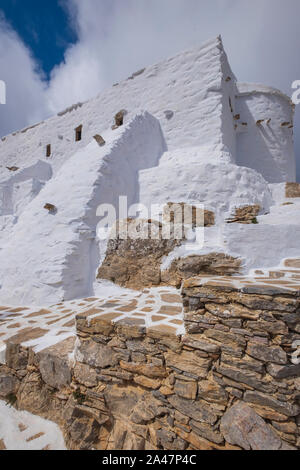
[97,219,183,289]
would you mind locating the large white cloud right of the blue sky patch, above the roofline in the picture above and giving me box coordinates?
[45,0,300,111]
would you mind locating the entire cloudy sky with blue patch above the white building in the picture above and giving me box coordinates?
[0,0,300,181]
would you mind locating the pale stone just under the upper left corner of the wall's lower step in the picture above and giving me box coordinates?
[77,340,118,368]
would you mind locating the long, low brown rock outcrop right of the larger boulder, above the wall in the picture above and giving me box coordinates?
[162,253,241,286]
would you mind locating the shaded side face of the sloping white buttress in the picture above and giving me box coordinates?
[63,112,167,300]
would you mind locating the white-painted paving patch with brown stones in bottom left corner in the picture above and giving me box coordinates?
[0,401,66,451]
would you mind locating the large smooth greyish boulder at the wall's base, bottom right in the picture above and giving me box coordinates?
[220,403,282,450]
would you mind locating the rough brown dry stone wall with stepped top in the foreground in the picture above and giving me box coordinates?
[0,278,300,450]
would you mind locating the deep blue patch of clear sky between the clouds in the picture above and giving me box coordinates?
[0,0,76,78]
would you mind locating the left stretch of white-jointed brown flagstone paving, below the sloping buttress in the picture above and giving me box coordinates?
[0,287,184,363]
